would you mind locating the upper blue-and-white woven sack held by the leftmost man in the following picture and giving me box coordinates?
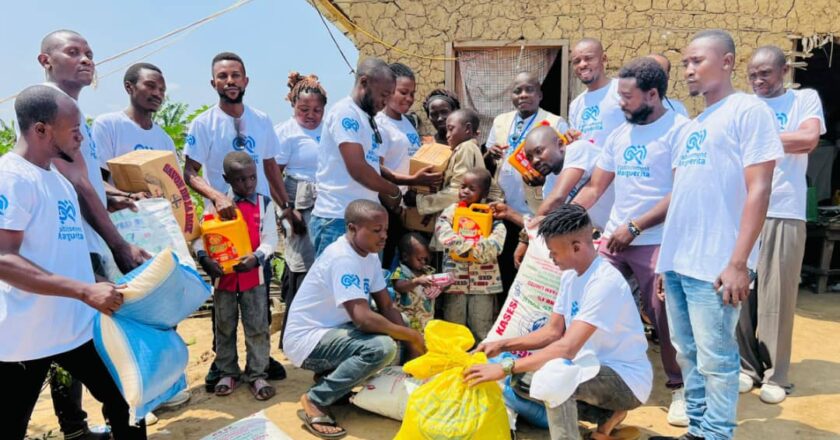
[116,249,211,330]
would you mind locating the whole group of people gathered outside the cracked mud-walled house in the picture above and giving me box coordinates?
[0,25,825,440]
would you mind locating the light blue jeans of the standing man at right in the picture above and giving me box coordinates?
[664,272,741,440]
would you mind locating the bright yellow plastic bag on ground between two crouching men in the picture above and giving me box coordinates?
[395,320,510,440]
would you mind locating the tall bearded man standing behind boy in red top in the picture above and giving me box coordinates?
[184,52,293,389]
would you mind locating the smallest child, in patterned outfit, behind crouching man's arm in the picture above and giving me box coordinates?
[391,232,441,333]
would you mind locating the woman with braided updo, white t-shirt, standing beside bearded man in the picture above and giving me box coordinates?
[274,72,327,348]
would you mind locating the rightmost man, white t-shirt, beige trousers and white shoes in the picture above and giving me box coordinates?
[738,46,825,403]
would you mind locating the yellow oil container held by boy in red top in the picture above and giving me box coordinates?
[201,209,253,274]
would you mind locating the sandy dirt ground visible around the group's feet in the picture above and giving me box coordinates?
[23,290,840,440]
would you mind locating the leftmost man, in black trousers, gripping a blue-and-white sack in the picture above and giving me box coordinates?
[0,85,146,439]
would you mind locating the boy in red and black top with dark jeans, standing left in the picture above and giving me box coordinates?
[196,151,277,400]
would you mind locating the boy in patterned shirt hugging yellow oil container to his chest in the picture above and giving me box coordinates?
[435,167,507,341]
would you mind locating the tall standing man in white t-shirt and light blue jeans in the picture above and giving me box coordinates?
[656,30,783,439]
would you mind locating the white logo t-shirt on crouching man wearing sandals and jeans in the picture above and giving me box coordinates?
[283,236,385,367]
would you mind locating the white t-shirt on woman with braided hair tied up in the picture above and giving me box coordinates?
[274,118,324,182]
